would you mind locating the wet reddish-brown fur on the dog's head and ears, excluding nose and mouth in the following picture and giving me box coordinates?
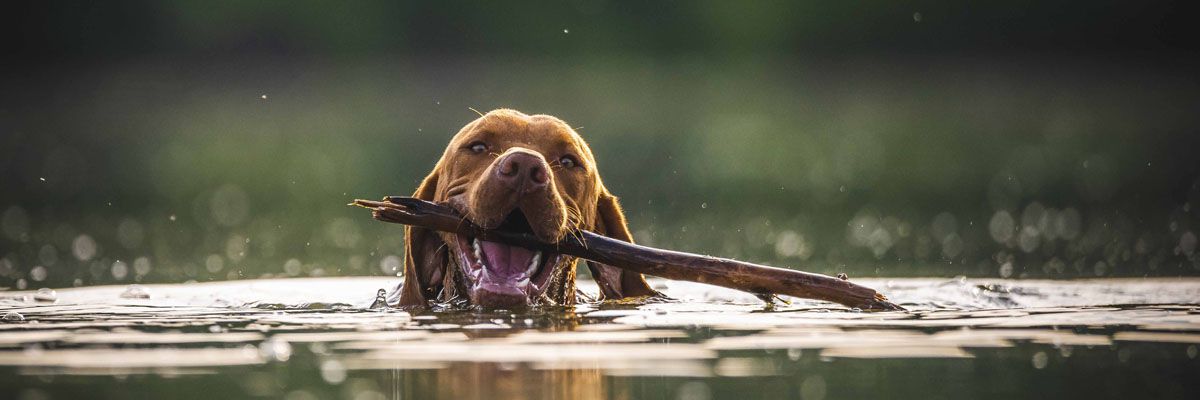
[396,109,658,308]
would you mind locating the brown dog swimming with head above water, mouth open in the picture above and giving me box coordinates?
[398,109,658,309]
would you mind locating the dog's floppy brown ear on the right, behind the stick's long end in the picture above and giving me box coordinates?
[588,190,659,299]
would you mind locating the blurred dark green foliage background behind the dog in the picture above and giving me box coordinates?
[0,1,1200,287]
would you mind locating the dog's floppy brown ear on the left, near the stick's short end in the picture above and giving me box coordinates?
[400,168,448,306]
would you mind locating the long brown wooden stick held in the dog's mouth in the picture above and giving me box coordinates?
[352,196,904,311]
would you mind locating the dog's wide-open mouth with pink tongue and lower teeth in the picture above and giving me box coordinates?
[455,209,560,309]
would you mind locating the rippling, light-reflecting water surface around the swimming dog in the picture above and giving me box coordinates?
[0,277,1200,400]
